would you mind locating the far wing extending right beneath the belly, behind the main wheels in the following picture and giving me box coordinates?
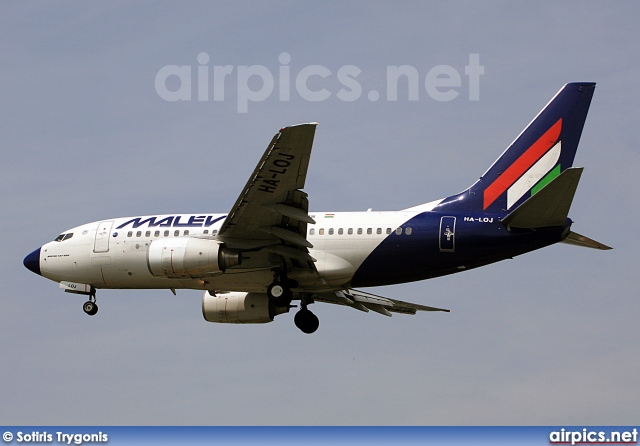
[313,290,449,316]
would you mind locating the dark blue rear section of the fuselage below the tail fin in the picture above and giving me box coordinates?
[351,212,571,287]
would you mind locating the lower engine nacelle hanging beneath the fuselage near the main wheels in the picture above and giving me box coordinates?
[202,291,289,324]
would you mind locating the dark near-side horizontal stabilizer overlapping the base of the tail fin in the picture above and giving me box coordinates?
[502,167,582,229]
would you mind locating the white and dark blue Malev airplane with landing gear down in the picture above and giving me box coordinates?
[23,82,611,334]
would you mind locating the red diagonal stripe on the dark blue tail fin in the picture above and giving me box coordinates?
[484,118,562,209]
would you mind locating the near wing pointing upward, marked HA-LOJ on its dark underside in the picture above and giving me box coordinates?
[218,123,317,262]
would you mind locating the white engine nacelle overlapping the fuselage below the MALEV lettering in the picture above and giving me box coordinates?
[147,237,242,279]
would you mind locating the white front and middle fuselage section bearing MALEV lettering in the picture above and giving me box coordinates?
[40,210,428,292]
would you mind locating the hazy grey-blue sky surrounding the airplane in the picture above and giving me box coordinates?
[0,1,640,425]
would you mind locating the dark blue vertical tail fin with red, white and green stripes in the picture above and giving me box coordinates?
[438,82,596,215]
